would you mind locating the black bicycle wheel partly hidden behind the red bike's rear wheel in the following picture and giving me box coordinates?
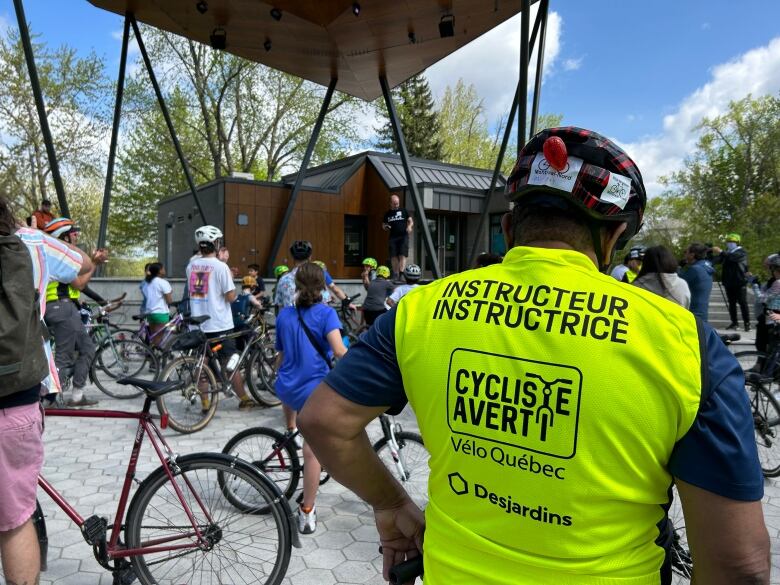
[220,427,303,507]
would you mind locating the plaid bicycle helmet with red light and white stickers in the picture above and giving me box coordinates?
[506,126,647,265]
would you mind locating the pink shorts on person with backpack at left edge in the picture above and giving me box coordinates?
[0,403,43,532]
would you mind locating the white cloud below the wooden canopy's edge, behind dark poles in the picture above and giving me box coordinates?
[426,3,563,123]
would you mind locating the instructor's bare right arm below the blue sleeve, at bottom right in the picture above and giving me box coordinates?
[675,480,771,585]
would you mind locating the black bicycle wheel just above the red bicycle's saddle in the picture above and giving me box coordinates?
[89,339,160,399]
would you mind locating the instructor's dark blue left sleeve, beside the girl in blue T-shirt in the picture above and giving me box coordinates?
[325,308,407,414]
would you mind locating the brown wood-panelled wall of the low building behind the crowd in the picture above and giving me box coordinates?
[225,164,396,278]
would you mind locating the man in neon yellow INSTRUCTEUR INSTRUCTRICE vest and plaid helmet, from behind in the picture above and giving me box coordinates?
[299,127,770,585]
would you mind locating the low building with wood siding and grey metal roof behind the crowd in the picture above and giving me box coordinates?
[158,152,507,278]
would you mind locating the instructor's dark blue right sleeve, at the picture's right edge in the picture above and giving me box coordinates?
[669,324,764,501]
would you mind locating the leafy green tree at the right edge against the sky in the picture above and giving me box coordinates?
[655,95,780,278]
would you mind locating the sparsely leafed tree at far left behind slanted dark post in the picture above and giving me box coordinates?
[0,27,110,242]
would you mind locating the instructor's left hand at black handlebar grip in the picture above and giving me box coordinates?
[374,499,425,581]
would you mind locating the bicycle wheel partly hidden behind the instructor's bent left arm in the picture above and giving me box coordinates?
[374,431,430,508]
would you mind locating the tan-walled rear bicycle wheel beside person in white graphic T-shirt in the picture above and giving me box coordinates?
[157,355,220,434]
